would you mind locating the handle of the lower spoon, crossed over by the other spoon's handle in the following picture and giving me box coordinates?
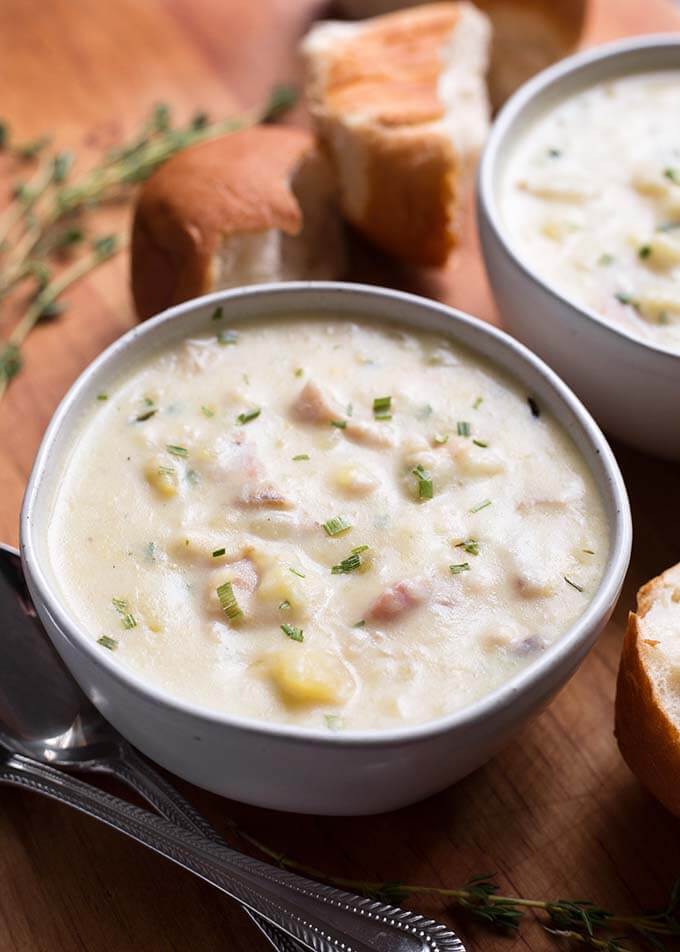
[109,743,303,952]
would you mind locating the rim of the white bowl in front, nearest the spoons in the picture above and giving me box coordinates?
[20,281,632,747]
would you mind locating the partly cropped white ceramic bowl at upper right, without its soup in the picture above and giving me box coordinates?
[477,35,680,459]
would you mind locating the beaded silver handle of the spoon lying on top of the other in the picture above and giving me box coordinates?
[0,754,465,952]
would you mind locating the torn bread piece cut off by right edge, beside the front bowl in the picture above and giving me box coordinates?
[616,564,680,816]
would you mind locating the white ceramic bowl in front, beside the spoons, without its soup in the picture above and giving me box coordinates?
[21,282,631,814]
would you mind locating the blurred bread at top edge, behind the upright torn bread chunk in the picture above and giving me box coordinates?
[336,0,587,108]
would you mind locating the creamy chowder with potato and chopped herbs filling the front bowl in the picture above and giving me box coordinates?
[49,318,609,730]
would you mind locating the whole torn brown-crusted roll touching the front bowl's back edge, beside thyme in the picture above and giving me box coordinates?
[132,126,344,319]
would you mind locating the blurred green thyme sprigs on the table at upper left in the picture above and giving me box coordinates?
[0,86,295,399]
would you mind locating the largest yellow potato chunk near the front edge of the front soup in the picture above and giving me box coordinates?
[270,644,351,705]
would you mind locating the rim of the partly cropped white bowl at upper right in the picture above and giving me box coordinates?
[476,33,680,364]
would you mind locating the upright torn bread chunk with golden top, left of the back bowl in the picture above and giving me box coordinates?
[302,3,490,265]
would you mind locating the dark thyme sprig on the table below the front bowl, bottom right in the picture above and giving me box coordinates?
[220,821,680,952]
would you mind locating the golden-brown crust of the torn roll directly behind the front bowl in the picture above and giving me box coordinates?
[131,126,315,320]
